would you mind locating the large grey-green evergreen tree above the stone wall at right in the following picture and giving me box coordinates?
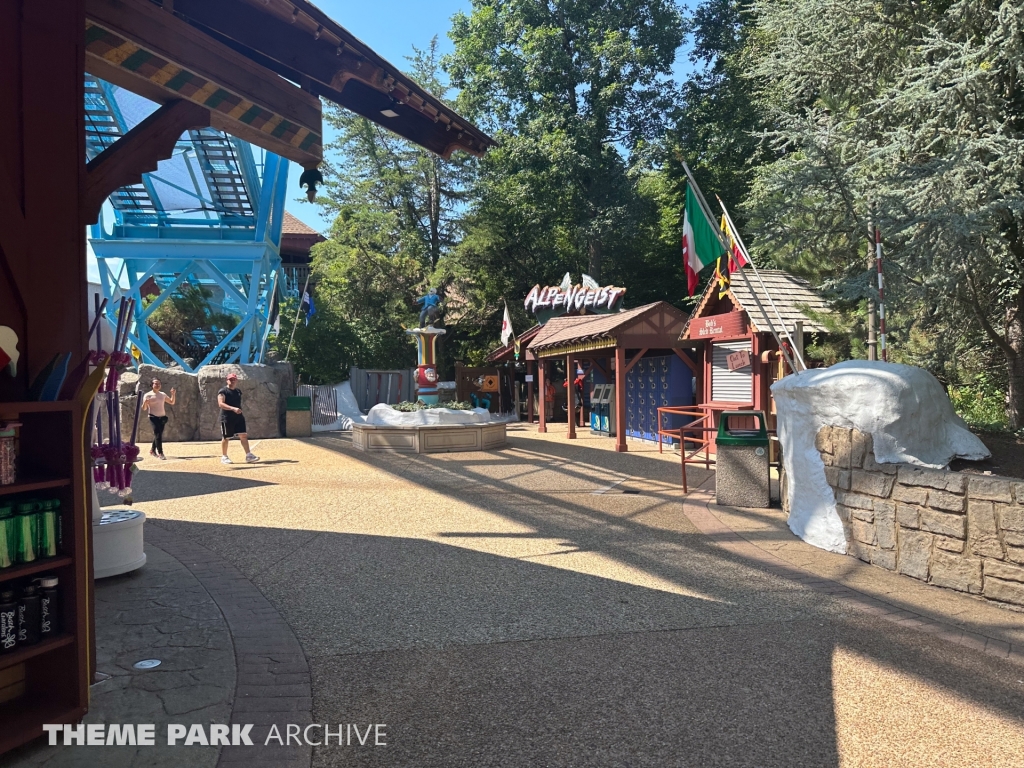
[748,0,1024,428]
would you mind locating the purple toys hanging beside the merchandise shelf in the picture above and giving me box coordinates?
[89,294,142,503]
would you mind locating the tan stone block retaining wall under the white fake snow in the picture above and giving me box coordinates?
[815,427,1024,606]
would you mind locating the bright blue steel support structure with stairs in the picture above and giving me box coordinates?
[85,77,288,371]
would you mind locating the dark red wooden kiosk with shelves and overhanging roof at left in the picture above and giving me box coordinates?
[0,0,494,754]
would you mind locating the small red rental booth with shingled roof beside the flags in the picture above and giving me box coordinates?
[680,269,833,450]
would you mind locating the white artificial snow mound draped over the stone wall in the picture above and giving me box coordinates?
[771,360,991,553]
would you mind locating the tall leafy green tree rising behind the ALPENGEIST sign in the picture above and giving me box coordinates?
[444,0,683,288]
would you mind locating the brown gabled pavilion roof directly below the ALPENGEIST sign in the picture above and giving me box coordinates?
[529,301,687,357]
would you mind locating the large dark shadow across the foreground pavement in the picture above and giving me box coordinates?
[149,512,1024,768]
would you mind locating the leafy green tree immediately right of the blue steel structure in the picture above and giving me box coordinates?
[292,39,475,383]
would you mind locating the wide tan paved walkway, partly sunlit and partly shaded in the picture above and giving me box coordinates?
[16,426,1024,768]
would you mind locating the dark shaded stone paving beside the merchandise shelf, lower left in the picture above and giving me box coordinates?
[7,544,237,768]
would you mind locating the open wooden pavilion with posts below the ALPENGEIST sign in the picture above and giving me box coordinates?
[529,301,700,452]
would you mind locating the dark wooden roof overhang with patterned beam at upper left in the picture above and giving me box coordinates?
[85,0,495,168]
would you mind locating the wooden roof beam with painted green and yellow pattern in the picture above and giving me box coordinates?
[85,0,323,168]
